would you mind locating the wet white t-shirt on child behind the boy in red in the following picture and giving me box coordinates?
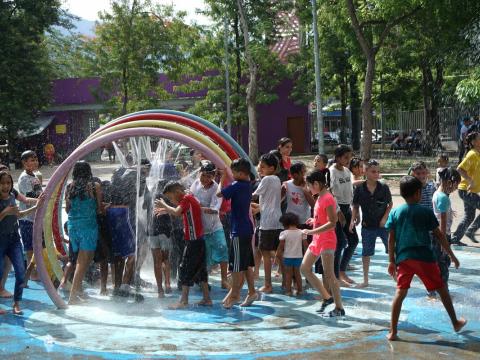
[190,179,223,234]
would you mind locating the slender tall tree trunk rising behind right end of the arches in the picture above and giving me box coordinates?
[237,0,258,163]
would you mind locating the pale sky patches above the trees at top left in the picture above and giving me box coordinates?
[63,0,209,24]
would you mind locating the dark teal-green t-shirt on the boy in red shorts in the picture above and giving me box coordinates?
[385,204,438,264]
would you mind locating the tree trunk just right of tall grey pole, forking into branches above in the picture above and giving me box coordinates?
[360,52,375,160]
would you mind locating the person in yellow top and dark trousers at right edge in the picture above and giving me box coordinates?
[452,132,480,245]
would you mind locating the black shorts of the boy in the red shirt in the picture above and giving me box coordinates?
[178,238,208,286]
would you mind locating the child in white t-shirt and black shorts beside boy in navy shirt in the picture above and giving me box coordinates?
[253,153,282,294]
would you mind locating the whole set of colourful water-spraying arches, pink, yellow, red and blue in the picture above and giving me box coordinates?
[33,110,256,309]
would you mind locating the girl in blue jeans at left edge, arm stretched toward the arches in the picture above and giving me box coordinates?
[0,171,36,315]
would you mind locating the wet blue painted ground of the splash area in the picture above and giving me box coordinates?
[0,244,480,359]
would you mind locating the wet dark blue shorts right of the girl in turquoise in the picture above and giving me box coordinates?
[107,207,136,257]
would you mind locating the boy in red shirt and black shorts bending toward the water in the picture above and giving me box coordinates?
[155,181,212,310]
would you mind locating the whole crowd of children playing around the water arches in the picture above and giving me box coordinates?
[0,132,480,340]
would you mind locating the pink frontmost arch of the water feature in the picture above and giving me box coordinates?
[33,127,229,309]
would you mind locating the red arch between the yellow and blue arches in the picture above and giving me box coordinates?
[97,113,239,160]
